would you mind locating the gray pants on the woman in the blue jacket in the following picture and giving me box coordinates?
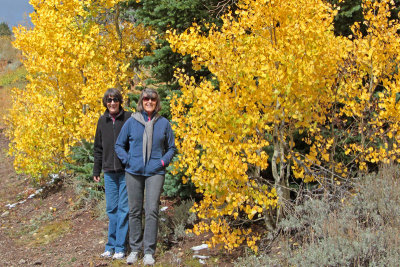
[125,172,164,255]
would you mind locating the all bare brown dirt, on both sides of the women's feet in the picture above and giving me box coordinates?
[0,129,234,266]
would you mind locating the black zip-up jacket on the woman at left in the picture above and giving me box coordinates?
[93,109,132,176]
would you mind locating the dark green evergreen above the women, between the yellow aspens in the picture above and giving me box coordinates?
[124,0,233,119]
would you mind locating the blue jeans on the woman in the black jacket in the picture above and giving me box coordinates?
[104,172,129,252]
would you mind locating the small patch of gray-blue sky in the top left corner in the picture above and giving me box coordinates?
[0,0,33,28]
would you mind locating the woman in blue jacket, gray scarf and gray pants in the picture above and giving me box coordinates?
[115,89,176,265]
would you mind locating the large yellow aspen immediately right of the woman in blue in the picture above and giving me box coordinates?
[169,0,349,250]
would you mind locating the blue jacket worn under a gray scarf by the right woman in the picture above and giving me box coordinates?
[115,112,176,176]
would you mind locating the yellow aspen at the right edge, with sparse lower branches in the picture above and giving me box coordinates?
[294,0,400,183]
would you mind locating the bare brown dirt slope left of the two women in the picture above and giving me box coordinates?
[0,129,107,266]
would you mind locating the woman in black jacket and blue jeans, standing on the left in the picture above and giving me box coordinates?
[93,88,132,259]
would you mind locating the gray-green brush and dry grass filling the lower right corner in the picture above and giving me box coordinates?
[236,166,400,266]
